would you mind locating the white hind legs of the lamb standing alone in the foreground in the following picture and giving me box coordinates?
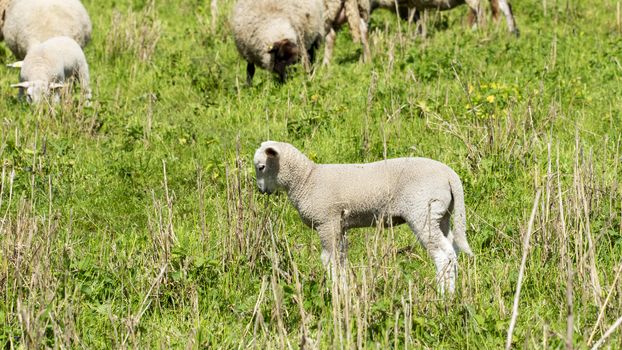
[408,201,458,295]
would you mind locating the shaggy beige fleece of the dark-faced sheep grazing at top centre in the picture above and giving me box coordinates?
[231,0,324,69]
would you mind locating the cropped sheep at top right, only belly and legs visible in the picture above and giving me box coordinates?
[371,0,519,36]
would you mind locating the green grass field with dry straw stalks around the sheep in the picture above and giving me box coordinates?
[0,0,622,349]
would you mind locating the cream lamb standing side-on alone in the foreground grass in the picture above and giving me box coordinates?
[254,141,473,293]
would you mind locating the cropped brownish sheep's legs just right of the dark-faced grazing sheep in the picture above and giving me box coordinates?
[323,0,371,65]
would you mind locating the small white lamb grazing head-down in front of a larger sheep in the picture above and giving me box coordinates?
[10,36,91,103]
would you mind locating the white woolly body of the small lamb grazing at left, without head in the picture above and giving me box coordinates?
[20,36,88,83]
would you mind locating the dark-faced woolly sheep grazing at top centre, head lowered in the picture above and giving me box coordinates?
[231,0,324,85]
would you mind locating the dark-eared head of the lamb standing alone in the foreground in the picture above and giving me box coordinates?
[254,142,281,194]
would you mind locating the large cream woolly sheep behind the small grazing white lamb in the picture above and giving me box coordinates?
[3,0,92,59]
